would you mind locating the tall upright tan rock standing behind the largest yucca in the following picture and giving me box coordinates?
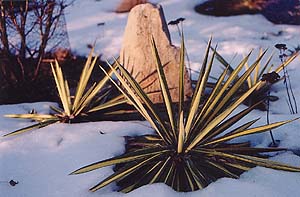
[120,4,192,103]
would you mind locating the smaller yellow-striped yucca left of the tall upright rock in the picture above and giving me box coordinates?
[4,49,127,136]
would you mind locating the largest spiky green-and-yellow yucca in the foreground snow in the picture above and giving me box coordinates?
[71,35,300,192]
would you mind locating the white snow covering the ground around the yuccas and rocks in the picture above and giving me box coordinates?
[0,0,300,197]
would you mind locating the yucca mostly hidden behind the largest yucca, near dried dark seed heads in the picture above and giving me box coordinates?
[211,48,298,110]
